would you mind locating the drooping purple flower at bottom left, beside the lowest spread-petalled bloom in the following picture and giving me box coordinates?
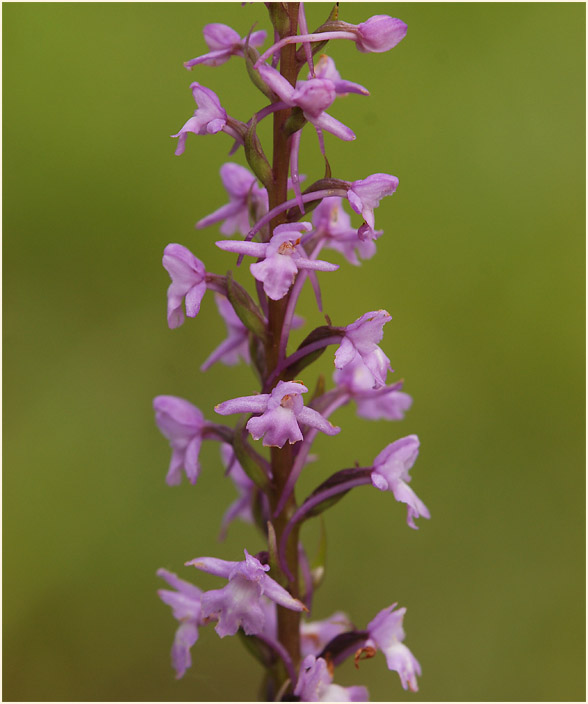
[157,568,204,679]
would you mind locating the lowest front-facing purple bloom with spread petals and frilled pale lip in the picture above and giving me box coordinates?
[186,550,306,638]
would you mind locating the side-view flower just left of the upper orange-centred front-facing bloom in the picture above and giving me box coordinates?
[163,244,206,329]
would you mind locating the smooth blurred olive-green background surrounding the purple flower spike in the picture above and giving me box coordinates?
[3,3,585,701]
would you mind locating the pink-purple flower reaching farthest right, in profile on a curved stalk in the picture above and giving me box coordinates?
[371,435,431,530]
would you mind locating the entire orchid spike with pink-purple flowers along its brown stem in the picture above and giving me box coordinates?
[153,3,430,701]
